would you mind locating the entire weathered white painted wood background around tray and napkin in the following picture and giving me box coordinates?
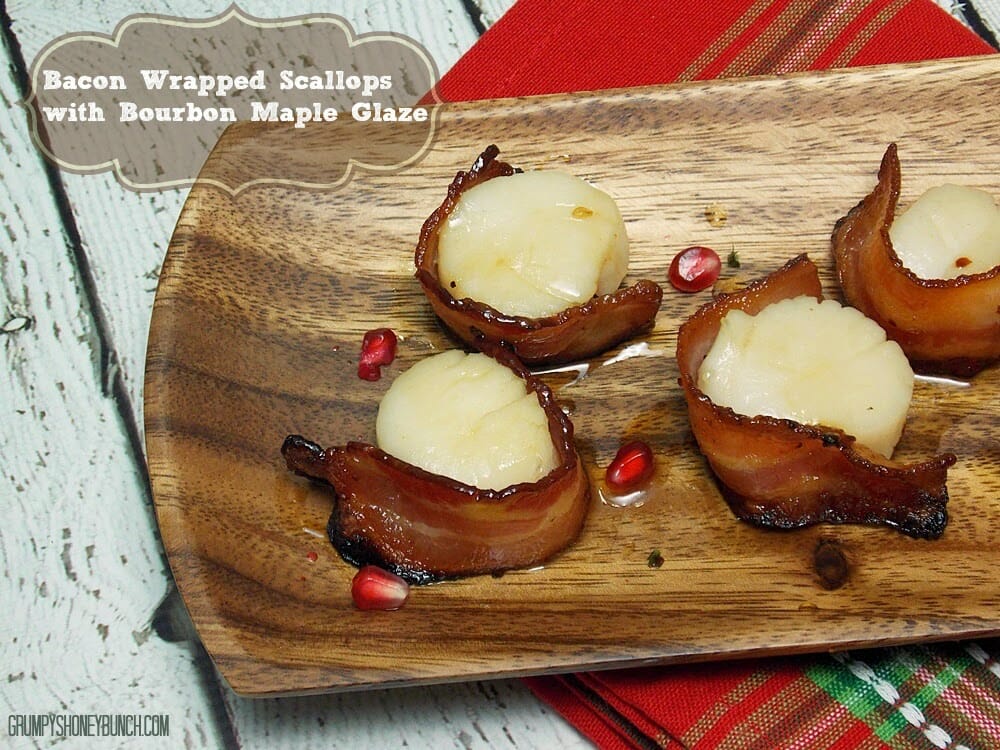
[0,0,1000,750]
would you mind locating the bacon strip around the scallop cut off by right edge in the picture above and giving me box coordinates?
[833,144,1000,376]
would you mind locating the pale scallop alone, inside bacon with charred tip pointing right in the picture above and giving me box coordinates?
[698,296,913,458]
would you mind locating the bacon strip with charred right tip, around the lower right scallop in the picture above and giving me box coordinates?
[677,255,955,538]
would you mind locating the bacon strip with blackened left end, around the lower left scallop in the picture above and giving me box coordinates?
[281,350,590,583]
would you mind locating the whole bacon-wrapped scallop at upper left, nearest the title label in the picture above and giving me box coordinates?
[415,146,663,364]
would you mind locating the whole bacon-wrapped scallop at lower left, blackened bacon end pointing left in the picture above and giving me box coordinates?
[282,345,590,583]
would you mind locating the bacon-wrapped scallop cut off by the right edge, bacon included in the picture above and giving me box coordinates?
[832,144,1000,376]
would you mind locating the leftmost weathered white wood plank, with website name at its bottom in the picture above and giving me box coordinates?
[0,39,227,748]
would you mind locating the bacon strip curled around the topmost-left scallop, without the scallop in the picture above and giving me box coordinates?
[414,145,663,364]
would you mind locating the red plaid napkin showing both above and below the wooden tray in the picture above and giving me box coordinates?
[438,0,1000,750]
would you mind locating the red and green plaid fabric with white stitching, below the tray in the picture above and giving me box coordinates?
[526,641,1000,750]
